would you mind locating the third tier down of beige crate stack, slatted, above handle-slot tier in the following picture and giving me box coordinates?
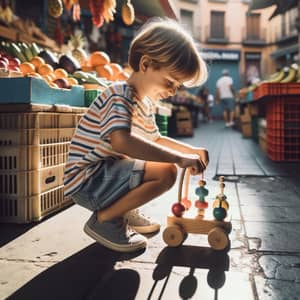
[0,142,70,172]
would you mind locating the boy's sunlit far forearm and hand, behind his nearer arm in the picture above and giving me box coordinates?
[155,136,209,166]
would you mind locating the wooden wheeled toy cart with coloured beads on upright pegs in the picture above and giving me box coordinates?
[163,169,232,250]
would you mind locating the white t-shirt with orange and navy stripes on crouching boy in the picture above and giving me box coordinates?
[64,82,160,196]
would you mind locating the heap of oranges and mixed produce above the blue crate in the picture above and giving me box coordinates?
[0,36,129,90]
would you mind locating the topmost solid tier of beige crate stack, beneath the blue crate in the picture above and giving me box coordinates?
[0,112,82,129]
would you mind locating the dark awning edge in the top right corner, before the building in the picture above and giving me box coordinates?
[249,0,299,19]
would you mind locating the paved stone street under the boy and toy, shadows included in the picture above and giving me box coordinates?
[0,121,300,300]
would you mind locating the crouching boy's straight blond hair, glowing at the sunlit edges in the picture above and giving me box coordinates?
[128,19,207,87]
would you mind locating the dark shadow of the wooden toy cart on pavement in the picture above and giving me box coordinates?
[147,246,229,300]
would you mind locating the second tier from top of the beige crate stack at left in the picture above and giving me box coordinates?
[0,128,75,146]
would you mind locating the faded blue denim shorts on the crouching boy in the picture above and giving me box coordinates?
[72,159,145,211]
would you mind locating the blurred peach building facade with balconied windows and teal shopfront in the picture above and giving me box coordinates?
[173,0,298,93]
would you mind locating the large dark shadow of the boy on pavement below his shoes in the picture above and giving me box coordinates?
[7,243,144,300]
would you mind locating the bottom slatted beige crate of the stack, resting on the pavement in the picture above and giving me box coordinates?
[0,185,73,224]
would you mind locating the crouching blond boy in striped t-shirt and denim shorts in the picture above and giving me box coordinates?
[64,20,208,252]
